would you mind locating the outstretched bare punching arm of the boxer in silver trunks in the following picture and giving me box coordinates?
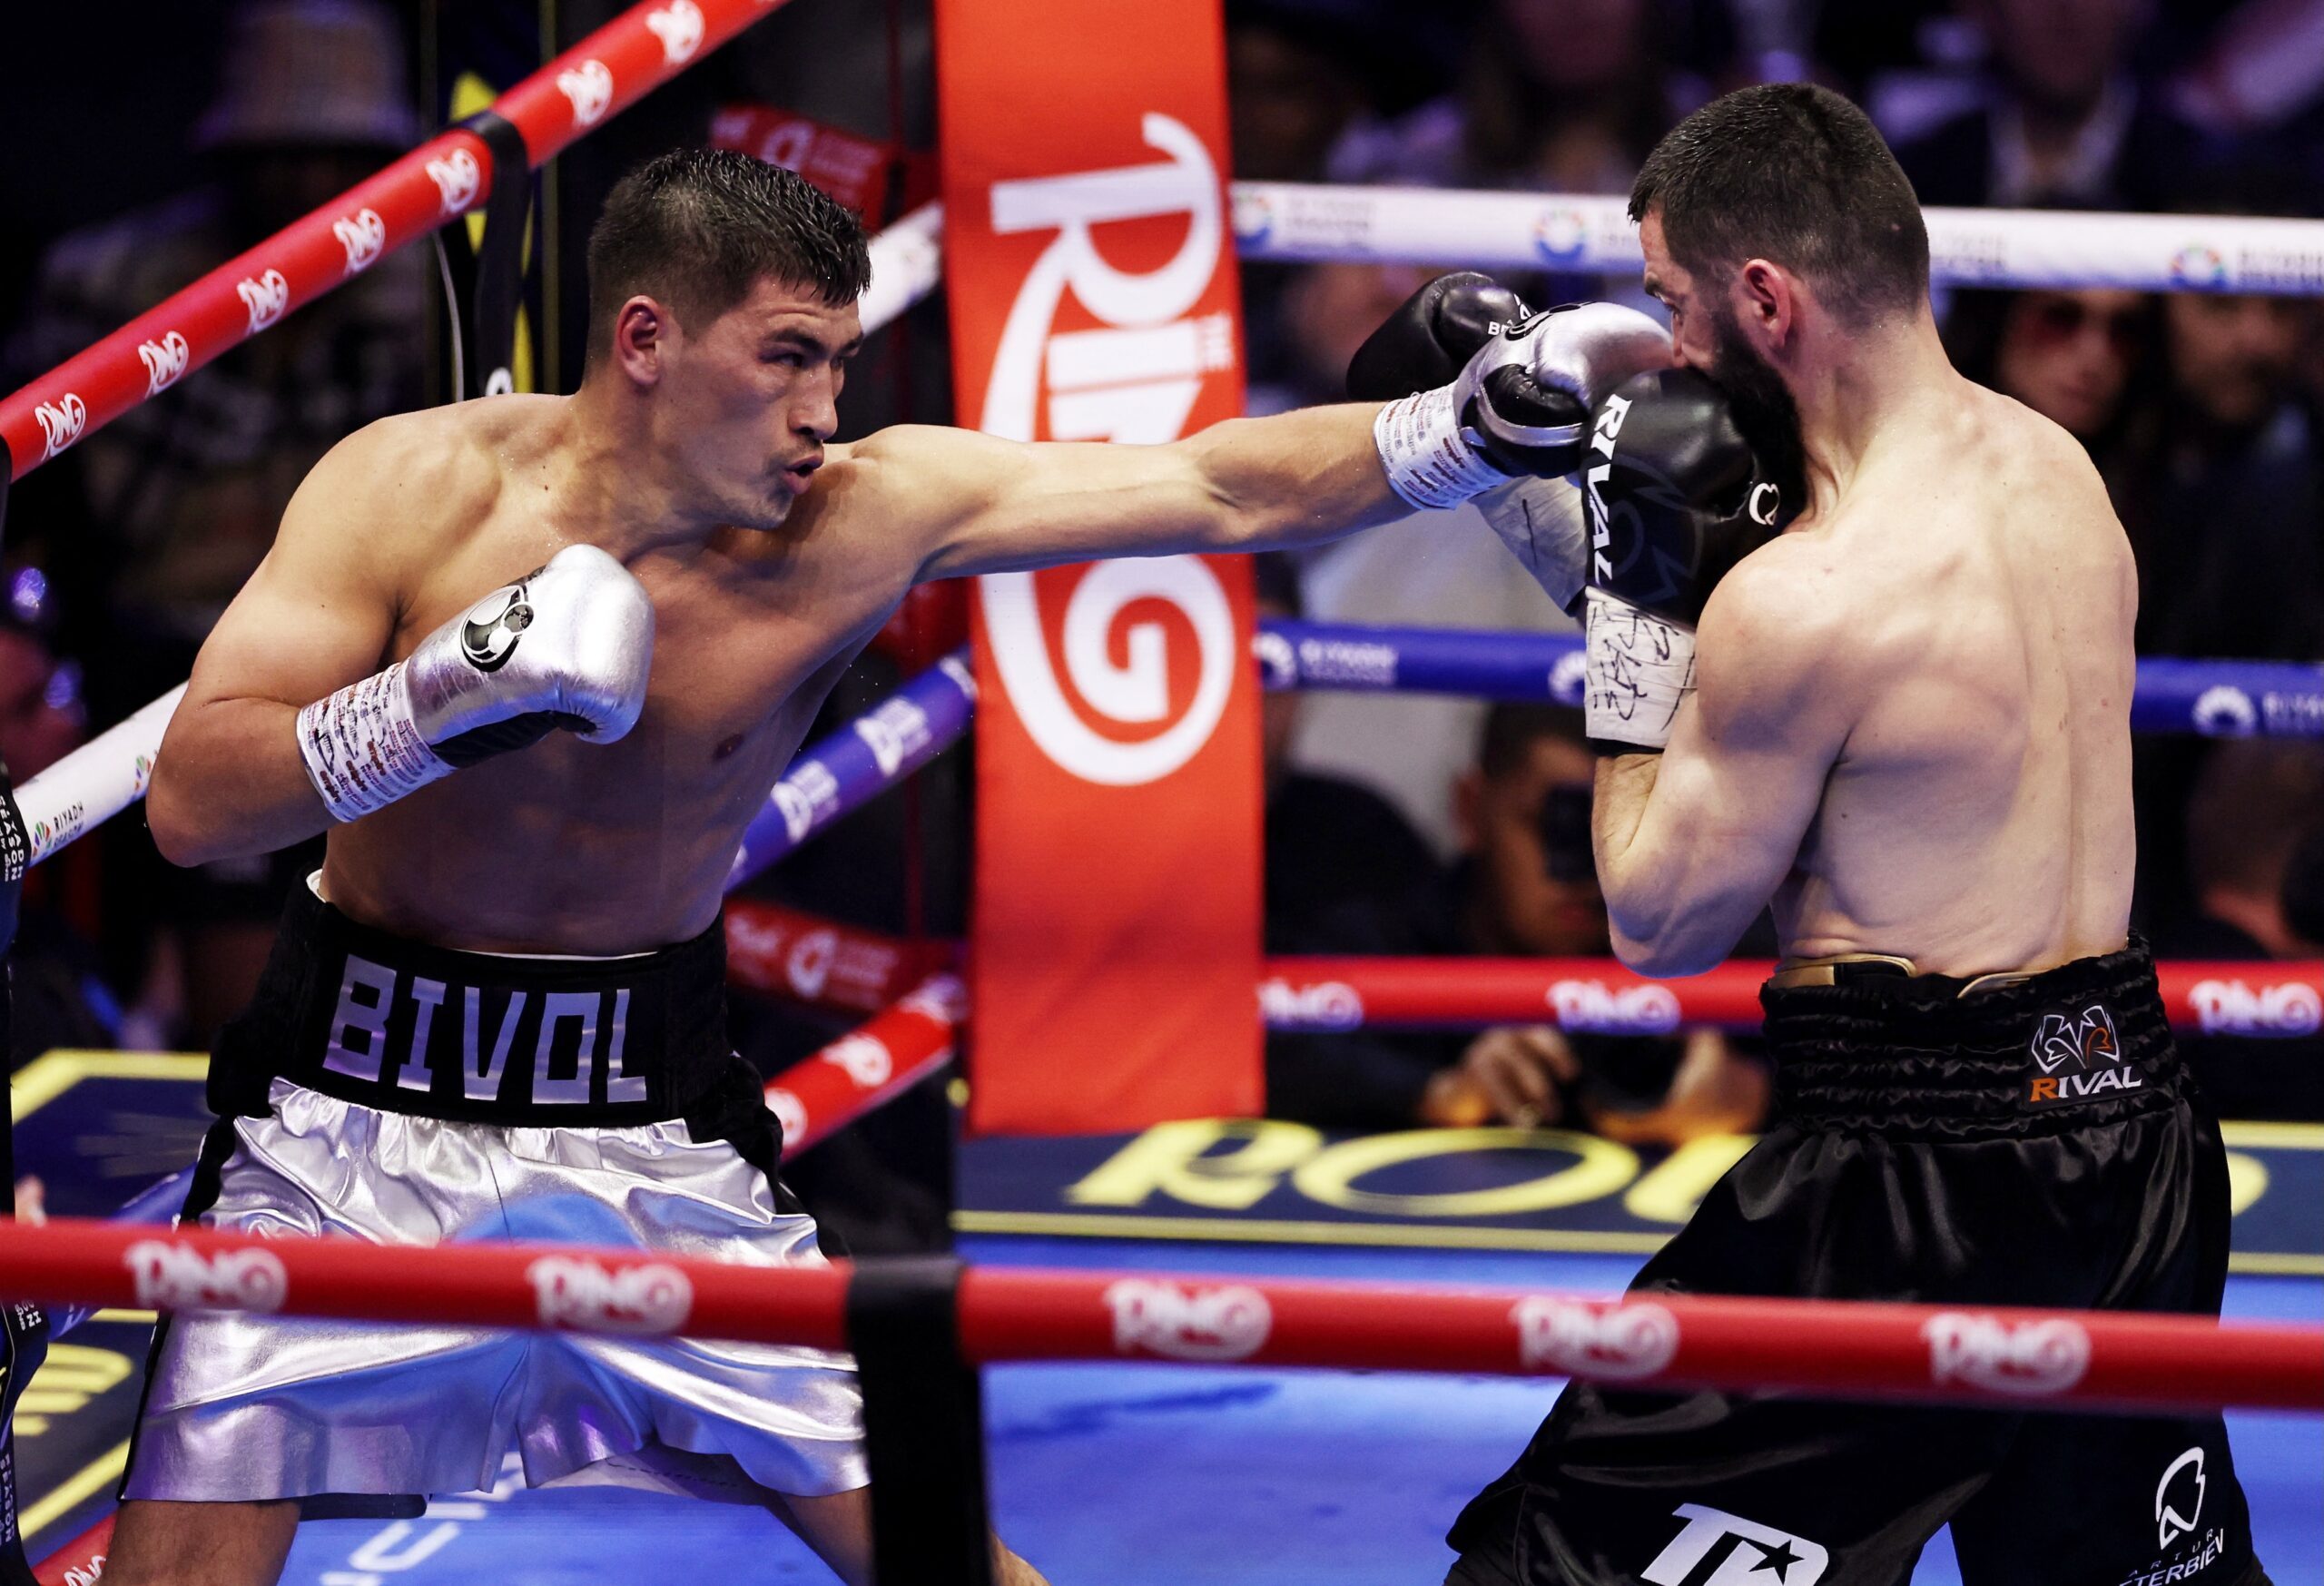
[851,402,1411,579]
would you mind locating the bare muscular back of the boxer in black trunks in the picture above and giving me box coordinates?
[1757,381,2136,974]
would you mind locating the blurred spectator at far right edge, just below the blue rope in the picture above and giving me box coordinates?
[2157,737,2324,1121]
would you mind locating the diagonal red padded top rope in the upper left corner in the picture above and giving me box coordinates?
[0,0,783,479]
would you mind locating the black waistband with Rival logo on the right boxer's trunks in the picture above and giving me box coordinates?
[1759,937,2178,1135]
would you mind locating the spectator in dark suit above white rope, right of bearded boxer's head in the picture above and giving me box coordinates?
[1896,0,2194,210]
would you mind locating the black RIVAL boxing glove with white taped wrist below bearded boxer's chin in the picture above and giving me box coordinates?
[1582,369,1797,754]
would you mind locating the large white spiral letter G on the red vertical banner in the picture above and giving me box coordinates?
[979,556,1236,788]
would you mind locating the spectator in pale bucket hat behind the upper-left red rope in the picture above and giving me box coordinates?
[7,0,425,1042]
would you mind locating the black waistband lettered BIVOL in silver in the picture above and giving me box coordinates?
[212,882,737,1126]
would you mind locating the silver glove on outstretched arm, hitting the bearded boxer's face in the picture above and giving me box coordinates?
[1371,302,1671,507]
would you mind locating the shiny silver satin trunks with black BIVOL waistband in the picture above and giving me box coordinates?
[123,886,867,1516]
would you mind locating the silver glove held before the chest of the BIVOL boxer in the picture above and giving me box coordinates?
[298,544,653,821]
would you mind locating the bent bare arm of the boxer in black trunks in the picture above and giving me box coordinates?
[1592,563,1852,974]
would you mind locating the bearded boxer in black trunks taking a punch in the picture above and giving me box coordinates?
[1357,84,2266,1586]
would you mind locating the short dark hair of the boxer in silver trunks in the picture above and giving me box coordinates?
[588,149,872,363]
